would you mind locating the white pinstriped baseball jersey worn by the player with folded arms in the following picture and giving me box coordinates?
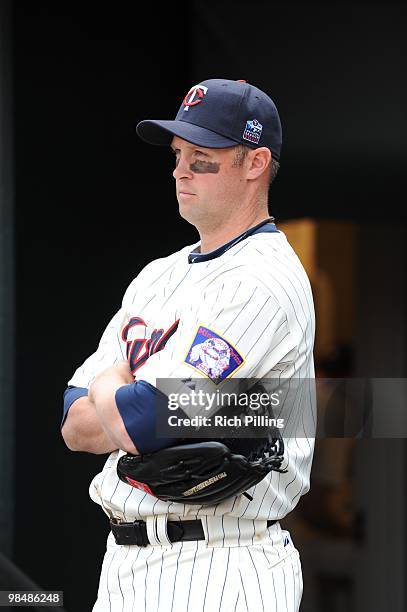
[68,227,315,528]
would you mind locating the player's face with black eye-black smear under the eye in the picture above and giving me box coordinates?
[171,136,245,229]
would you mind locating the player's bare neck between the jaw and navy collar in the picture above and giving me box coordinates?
[197,207,270,253]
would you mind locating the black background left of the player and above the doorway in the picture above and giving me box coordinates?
[3,1,407,612]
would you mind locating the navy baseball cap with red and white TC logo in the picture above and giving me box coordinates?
[136,79,282,161]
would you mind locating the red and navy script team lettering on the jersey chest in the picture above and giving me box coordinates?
[122,317,179,374]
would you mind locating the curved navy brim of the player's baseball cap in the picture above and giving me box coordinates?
[136,119,239,149]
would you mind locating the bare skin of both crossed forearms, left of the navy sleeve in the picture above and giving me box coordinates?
[62,361,138,454]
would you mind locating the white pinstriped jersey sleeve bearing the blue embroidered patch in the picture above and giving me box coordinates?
[135,277,298,387]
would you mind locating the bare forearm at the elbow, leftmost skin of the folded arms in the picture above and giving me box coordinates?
[62,397,119,454]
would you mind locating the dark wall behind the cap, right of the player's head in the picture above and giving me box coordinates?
[192,0,407,220]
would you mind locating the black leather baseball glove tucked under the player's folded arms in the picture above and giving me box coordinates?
[117,436,286,506]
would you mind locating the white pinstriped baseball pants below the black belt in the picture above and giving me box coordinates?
[93,517,303,612]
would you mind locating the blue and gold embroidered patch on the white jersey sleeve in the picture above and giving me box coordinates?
[185,326,244,385]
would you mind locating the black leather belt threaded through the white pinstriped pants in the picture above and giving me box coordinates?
[110,520,277,546]
